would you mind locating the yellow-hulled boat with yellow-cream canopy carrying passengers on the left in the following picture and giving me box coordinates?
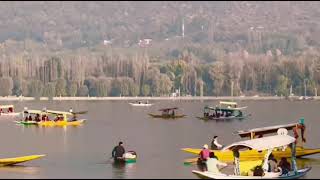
[15,110,86,127]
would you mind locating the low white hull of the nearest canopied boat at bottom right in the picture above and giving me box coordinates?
[192,167,311,179]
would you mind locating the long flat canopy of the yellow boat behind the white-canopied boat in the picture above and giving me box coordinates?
[236,123,299,138]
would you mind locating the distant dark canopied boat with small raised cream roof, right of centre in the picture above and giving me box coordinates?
[198,101,250,120]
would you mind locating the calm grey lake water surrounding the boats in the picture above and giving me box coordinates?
[0,101,320,178]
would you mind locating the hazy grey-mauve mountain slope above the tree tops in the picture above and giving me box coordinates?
[0,1,320,53]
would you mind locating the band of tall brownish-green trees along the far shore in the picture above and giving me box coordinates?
[0,42,320,97]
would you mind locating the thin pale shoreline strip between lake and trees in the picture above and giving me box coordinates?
[0,96,320,101]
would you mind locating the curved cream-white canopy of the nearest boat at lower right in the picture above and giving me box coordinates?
[222,135,295,151]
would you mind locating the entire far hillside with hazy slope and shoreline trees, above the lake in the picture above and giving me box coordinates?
[0,1,320,97]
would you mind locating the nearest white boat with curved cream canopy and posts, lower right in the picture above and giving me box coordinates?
[192,134,311,179]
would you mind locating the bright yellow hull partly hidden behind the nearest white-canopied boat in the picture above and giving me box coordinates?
[182,147,320,162]
